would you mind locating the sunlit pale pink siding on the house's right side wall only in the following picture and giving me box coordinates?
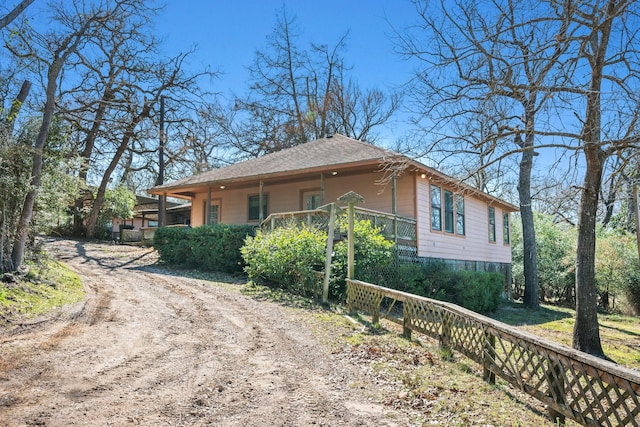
[416,176,511,263]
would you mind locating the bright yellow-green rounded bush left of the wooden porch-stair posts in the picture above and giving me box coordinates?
[241,224,327,289]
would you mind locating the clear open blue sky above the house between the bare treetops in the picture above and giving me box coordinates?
[157,0,417,129]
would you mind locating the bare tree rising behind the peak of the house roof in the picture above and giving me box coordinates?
[234,8,400,156]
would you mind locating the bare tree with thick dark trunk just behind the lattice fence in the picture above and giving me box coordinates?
[565,0,640,356]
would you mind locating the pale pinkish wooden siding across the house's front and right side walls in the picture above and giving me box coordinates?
[191,172,511,263]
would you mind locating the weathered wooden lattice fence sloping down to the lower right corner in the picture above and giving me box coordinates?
[347,280,640,426]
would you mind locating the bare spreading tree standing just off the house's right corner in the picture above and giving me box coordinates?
[399,1,568,308]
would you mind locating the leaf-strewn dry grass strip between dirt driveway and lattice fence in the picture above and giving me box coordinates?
[314,313,572,426]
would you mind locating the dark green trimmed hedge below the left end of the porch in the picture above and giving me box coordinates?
[153,224,254,273]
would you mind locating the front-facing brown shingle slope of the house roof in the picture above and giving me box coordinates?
[150,134,399,192]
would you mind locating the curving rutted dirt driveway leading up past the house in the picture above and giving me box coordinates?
[0,240,408,426]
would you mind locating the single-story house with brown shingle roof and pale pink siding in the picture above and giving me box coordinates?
[149,134,517,274]
